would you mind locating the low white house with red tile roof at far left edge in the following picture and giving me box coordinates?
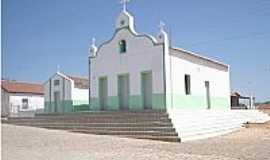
[1,80,44,117]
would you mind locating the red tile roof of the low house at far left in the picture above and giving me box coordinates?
[1,80,44,95]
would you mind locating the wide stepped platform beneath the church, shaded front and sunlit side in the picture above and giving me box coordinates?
[3,110,270,142]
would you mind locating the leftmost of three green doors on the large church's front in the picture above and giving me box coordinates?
[98,77,108,111]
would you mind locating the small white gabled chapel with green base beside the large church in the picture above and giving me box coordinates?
[44,72,89,113]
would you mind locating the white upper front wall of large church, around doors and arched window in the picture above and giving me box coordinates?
[90,28,164,97]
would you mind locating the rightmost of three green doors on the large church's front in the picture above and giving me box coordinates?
[141,72,153,109]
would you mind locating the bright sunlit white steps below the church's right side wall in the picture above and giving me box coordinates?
[169,110,270,141]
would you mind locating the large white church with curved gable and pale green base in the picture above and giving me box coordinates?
[89,6,230,111]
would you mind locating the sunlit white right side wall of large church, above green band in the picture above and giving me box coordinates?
[167,49,230,109]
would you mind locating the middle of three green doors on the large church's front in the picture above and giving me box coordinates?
[118,74,129,110]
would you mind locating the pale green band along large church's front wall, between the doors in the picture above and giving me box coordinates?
[90,93,166,111]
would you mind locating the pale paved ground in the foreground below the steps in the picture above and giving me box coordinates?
[2,119,270,160]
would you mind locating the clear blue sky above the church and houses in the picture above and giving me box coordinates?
[2,0,270,101]
